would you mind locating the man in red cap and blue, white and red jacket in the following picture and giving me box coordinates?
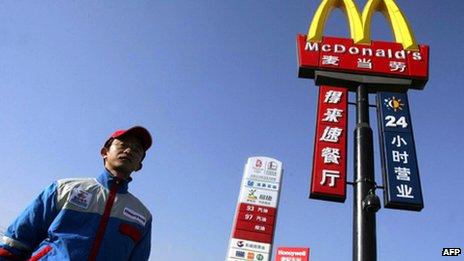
[0,126,152,260]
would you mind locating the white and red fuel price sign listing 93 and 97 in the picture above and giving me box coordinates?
[226,157,282,261]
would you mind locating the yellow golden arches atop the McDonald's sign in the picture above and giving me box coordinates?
[306,0,419,51]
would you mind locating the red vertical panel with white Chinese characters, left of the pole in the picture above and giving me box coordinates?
[310,85,348,202]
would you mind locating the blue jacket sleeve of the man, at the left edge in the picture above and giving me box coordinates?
[0,182,57,261]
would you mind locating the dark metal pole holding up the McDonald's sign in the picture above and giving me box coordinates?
[353,84,380,261]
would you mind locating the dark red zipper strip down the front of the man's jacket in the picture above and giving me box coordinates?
[89,179,121,261]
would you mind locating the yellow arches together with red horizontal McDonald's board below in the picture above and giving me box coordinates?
[297,0,429,91]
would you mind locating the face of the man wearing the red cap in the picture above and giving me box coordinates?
[101,136,145,178]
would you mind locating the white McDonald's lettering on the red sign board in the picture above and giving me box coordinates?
[305,42,422,61]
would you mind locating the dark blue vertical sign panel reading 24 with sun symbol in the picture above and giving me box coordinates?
[377,92,424,211]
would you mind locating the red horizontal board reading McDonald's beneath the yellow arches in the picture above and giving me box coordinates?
[297,35,429,89]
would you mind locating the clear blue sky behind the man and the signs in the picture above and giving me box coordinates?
[0,0,464,261]
